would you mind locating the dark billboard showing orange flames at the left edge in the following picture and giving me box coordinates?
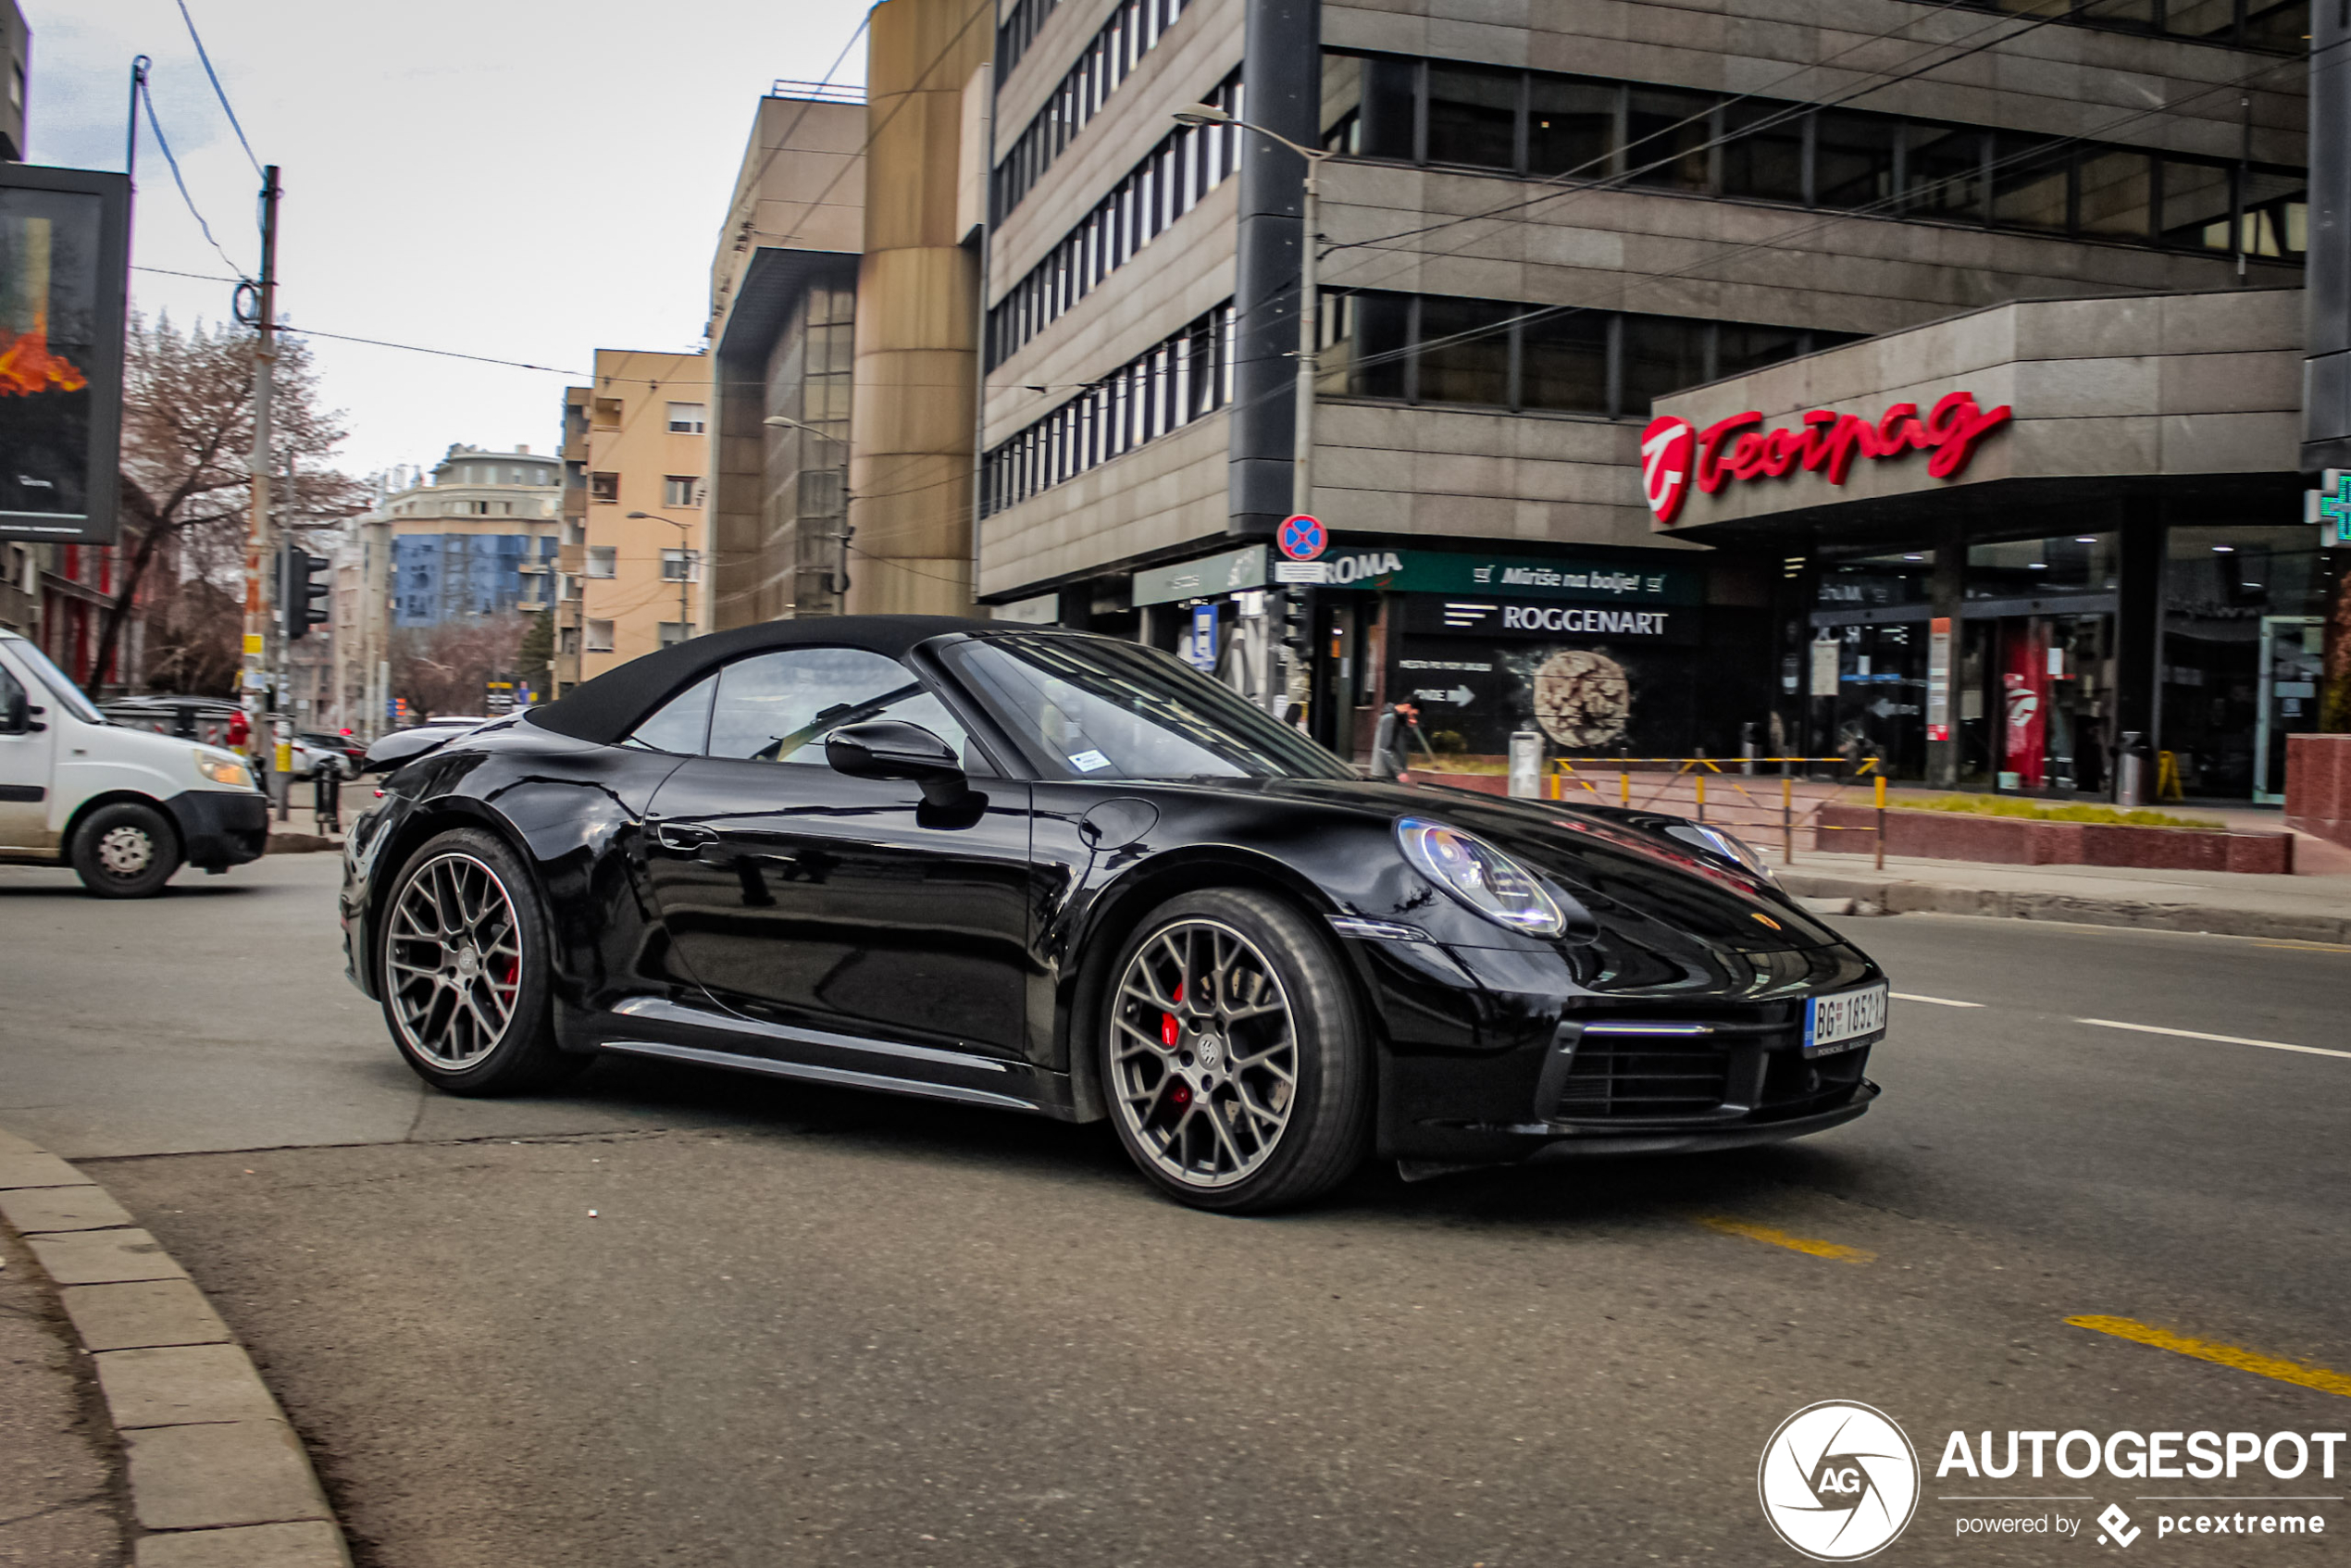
[0,165,130,545]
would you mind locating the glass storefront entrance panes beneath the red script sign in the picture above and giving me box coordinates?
[1782,524,2328,804]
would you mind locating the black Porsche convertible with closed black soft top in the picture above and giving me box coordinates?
[341,616,1885,1211]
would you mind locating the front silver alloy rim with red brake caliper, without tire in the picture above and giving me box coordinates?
[1110,919,1298,1188]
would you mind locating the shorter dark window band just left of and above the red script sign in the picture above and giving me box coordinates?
[1314,289,1864,418]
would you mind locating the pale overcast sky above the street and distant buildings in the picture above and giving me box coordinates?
[19,0,865,484]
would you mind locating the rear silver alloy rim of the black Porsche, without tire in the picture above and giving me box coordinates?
[383,853,522,1072]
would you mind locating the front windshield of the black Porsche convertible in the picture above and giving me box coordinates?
[940,632,1354,778]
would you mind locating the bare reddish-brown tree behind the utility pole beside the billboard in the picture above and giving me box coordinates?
[90,315,367,689]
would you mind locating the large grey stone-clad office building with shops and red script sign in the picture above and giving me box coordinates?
[976,0,2328,797]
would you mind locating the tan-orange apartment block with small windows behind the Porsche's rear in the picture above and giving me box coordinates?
[573,348,713,679]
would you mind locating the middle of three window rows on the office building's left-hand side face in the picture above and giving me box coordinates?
[988,70,1244,369]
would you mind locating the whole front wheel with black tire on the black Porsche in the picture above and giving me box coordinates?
[1091,889,1373,1213]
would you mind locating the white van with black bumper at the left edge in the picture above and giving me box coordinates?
[0,632,270,898]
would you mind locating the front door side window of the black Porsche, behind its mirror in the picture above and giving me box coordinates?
[708,649,971,766]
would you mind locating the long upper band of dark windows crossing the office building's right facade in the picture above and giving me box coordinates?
[1321,52,2308,258]
